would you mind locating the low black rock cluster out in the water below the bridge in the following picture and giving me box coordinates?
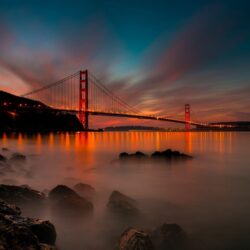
[119,149,192,161]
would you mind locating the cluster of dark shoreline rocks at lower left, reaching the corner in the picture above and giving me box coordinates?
[0,183,94,250]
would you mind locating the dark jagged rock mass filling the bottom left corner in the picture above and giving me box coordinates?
[0,198,56,250]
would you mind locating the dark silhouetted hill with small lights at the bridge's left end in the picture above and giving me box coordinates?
[0,91,83,132]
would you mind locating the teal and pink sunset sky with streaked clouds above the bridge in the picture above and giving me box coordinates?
[0,0,250,127]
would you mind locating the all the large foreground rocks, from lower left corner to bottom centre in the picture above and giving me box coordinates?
[0,183,186,250]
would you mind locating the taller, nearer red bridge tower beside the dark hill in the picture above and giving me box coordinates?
[79,70,89,130]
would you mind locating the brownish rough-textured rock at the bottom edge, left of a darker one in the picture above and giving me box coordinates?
[119,228,153,250]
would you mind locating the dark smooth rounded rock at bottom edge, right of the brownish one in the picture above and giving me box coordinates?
[150,224,186,250]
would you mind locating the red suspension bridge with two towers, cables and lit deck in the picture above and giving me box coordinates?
[18,70,209,130]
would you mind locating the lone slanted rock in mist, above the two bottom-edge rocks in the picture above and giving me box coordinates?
[107,191,140,215]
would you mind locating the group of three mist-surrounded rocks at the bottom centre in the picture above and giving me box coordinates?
[107,191,187,250]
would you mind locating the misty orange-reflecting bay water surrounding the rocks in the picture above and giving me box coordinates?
[0,132,250,250]
